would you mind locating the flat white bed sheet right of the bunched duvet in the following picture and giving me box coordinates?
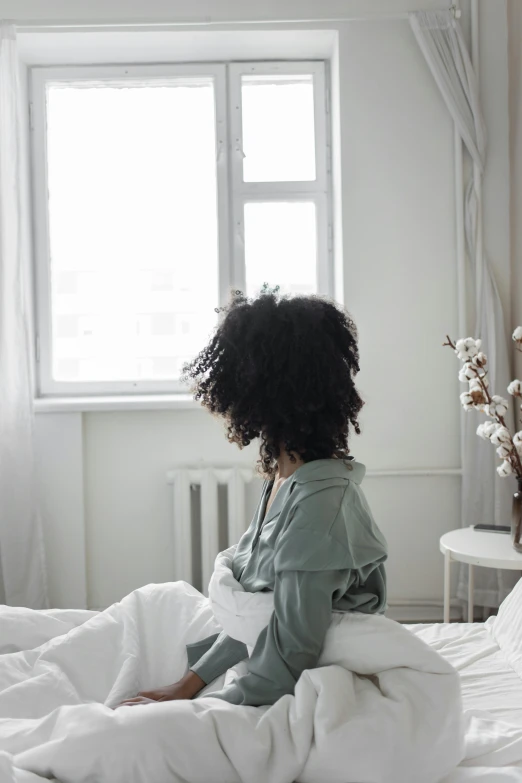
[409,621,522,783]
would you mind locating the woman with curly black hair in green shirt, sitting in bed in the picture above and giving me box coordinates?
[122,288,387,705]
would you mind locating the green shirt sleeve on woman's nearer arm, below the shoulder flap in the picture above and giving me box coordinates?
[209,570,346,706]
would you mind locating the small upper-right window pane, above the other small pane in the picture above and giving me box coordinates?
[241,74,315,182]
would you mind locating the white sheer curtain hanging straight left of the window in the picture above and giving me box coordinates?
[0,24,47,609]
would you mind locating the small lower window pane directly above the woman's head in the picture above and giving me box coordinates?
[245,201,317,296]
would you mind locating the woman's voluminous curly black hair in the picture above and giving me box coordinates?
[183,287,364,478]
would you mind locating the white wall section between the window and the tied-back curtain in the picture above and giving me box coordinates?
[332,16,460,617]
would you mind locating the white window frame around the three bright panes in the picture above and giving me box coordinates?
[29,61,333,398]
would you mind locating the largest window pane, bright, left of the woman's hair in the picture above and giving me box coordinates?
[47,78,218,381]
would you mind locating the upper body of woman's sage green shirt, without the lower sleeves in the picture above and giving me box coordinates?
[233,459,387,614]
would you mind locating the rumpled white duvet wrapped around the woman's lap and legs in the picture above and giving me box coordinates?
[0,553,463,783]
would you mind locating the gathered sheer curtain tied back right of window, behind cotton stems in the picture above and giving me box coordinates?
[410,11,518,607]
